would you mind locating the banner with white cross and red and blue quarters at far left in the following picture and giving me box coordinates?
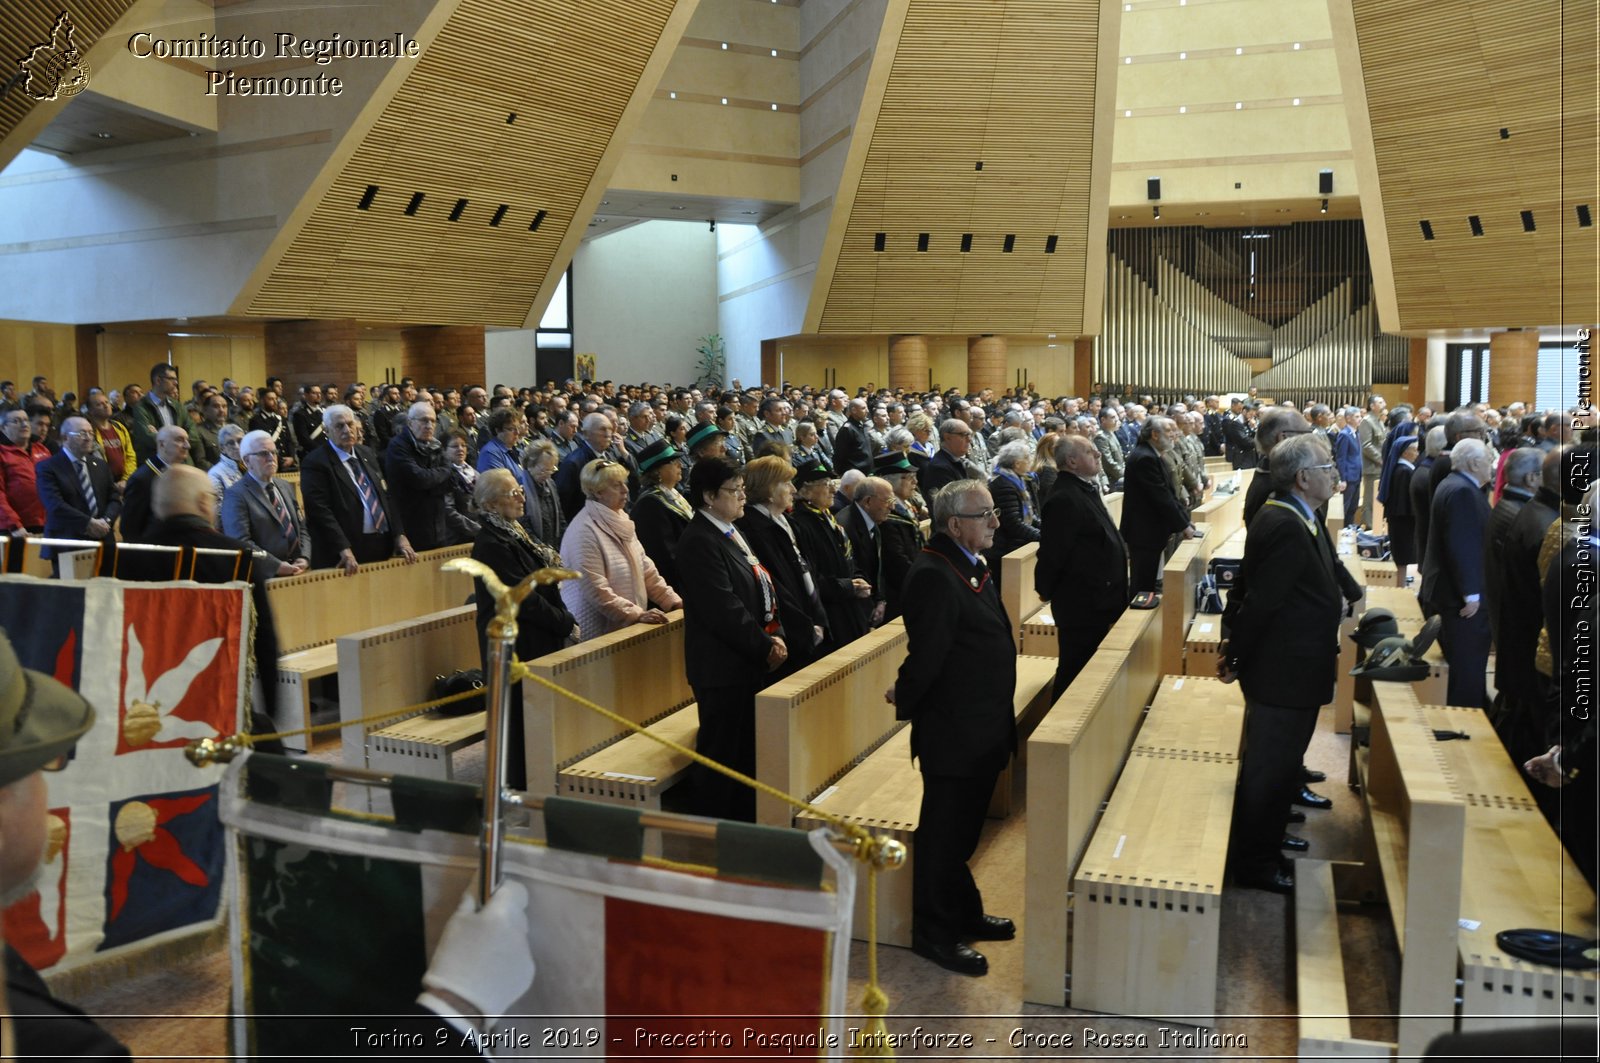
[0,576,250,975]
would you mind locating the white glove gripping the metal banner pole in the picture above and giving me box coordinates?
[418,879,533,1028]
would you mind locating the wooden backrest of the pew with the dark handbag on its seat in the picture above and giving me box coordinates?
[338,605,478,767]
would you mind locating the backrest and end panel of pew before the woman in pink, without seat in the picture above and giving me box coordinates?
[522,610,694,794]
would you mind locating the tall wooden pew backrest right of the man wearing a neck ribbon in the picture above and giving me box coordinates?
[1022,602,1166,1007]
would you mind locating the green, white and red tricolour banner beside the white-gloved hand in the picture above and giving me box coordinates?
[221,754,856,1058]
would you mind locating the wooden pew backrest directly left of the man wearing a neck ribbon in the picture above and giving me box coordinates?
[755,623,906,826]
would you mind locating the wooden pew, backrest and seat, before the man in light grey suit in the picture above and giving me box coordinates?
[267,546,472,752]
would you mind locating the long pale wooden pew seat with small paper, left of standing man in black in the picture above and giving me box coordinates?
[1072,676,1245,1025]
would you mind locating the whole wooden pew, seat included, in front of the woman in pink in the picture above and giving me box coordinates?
[522,610,699,808]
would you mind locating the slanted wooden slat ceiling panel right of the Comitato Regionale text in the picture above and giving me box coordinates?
[245,0,694,327]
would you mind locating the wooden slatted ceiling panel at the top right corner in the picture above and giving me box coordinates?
[1346,0,1600,331]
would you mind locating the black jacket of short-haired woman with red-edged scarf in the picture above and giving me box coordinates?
[674,514,790,692]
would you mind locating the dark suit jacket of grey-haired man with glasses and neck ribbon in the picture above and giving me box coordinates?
[894,533,1016,776]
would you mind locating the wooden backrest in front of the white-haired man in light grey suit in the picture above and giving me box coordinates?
[267,546,472,653]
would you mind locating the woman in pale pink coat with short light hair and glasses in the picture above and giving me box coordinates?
[562,458,683,640]
